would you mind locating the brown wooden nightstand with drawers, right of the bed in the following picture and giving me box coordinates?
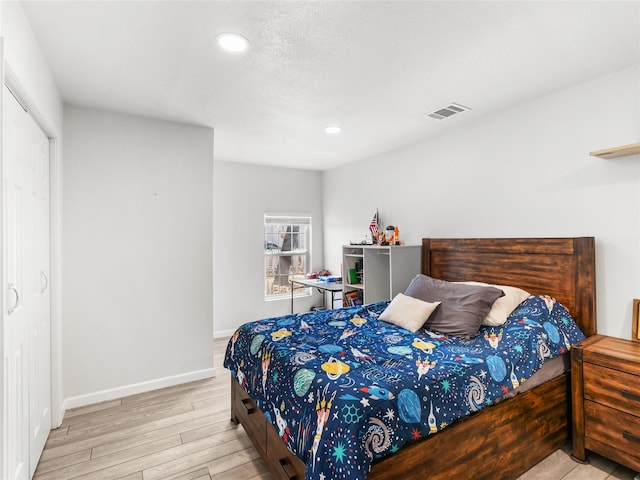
[571,335,640,471]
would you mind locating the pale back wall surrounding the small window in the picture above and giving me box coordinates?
[213,160,322,336]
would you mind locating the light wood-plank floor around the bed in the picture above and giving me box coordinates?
[34,339,634,480]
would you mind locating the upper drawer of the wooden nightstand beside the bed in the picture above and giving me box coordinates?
[583,363,640,416]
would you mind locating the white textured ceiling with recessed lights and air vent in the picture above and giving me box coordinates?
[22,0,640,170]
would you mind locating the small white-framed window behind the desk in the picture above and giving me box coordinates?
[264,214,311,300]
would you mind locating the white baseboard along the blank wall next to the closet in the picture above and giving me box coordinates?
[62,368,216,416]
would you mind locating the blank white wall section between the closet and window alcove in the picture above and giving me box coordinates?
[63,106,213,408]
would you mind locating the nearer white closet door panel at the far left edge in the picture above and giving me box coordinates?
[2,83,31,480]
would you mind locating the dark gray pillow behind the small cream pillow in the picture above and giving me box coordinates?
[404,274,504,338]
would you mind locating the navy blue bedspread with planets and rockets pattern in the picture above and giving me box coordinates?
[224,296,584,480]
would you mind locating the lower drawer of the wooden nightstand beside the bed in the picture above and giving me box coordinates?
[584,400,640,459]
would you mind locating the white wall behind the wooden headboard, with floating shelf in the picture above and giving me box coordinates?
[323,67,640,338]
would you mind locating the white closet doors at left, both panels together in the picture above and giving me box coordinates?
[0,87,51,479]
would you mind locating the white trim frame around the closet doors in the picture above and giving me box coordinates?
[0,58,64,434]
